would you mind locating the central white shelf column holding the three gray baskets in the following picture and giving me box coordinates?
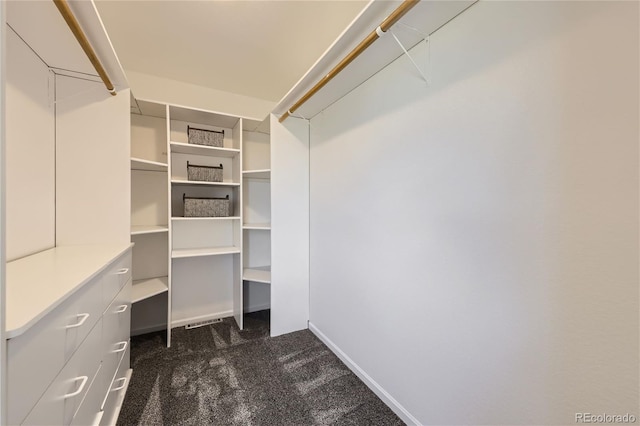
[168,105,242,327]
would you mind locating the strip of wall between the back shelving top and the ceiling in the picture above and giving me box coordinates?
[127,71,275,121]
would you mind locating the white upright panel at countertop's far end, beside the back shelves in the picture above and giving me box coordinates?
[56,75,131,245]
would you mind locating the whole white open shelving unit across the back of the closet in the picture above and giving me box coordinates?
[131,99,270,345]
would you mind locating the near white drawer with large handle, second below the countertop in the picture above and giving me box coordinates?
[23,322,102,425]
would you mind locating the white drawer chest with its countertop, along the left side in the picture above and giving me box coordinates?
[6,244,131,425]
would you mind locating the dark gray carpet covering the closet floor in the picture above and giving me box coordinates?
[118,311,404,426]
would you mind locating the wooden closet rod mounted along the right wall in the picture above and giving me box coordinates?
[279,0,420,123]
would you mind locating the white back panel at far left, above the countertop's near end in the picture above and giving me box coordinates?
[3,28,55,260]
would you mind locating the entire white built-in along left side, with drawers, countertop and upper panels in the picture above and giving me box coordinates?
[0,2,131,425]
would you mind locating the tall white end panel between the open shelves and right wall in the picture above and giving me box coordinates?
[271,115,309,336]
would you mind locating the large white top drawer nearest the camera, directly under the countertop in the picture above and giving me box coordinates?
[7,275,103,424]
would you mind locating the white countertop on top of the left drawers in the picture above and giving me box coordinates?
[5,243,132,339]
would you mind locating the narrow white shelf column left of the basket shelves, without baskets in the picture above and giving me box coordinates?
[131,99,170,334]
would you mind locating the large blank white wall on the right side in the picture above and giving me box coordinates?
[308,2,639,424]
